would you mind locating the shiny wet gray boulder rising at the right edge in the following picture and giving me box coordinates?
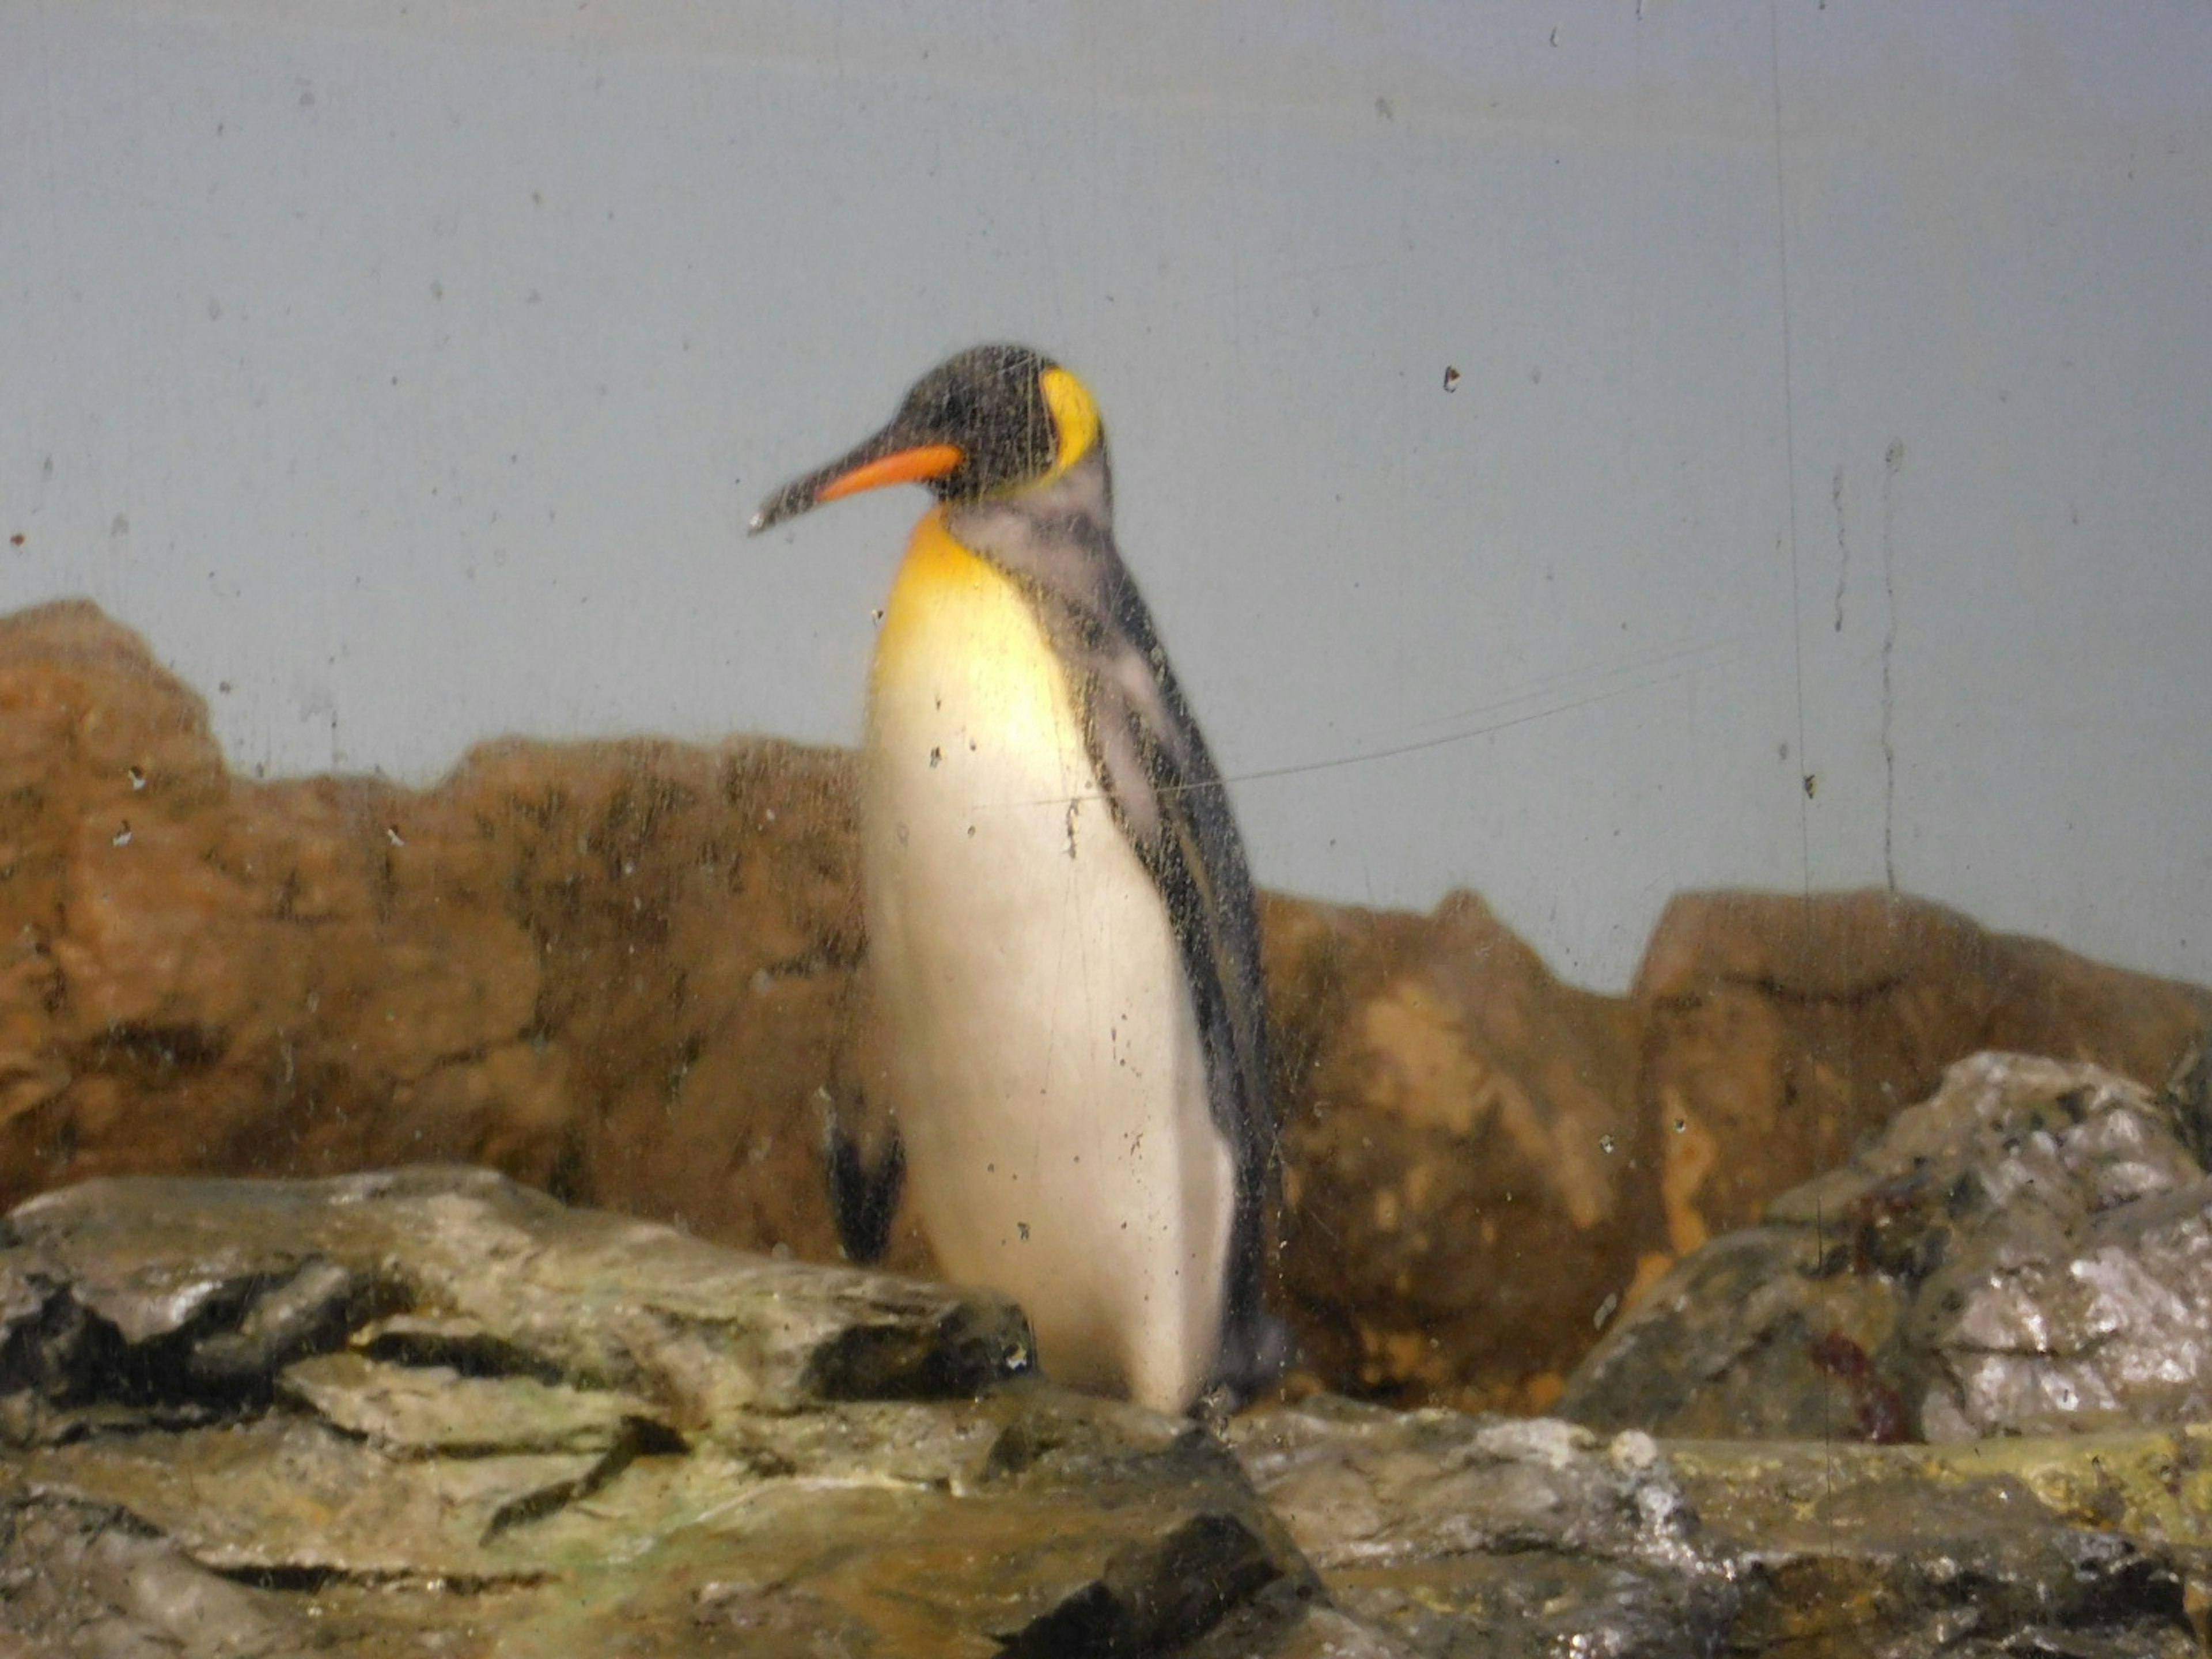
[1559,1055,2212,1442]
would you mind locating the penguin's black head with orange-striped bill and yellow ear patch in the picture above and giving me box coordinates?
[752,345,1099,535]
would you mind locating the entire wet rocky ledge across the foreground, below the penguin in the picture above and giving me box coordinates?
[0,1168,2212,1659]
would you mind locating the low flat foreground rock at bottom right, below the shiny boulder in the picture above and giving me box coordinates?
[1230,1400,2212,1659]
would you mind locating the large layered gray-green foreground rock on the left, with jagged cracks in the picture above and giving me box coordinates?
[0,1170,1312,1654]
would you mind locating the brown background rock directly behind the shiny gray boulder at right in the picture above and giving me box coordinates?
[1630,892,2212,1254]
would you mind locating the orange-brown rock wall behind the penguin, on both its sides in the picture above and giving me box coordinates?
[0,604,2212,1407]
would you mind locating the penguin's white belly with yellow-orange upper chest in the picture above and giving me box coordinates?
[861,522,1234,1411]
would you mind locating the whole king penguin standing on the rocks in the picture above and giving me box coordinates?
[752,345,1287,1411]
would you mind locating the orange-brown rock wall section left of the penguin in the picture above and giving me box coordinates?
[0,604,880,1256]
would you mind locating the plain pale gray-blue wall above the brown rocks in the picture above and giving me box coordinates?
[0,0,2212,987]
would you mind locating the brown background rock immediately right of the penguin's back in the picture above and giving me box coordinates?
[1265,893,1657,1407]
